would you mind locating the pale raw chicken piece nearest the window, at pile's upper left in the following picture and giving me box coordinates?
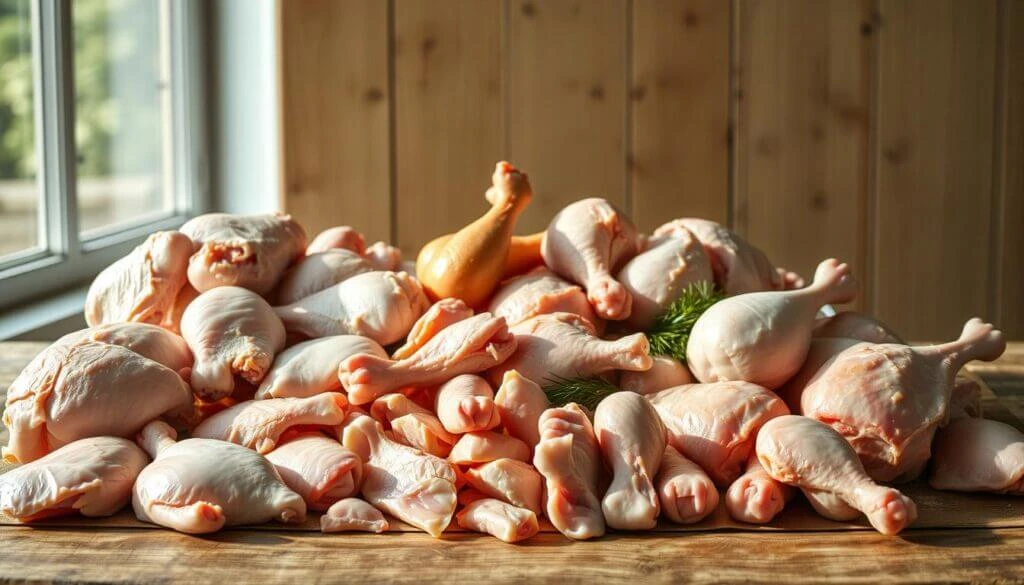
[85,232,193,331]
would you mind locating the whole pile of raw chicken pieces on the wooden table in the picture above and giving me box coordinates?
[0,163,1024,542]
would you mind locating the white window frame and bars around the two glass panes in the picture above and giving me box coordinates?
[0,0,210,310]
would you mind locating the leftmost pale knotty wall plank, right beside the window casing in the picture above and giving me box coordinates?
[278,0,391,242]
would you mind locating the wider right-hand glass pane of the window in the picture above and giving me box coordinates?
[72,0,174,237]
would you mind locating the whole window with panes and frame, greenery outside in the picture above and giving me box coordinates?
[0,0,208,308]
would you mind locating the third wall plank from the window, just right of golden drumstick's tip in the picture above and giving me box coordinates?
[508,0,628,234]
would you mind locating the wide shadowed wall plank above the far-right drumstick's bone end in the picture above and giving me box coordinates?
[873,0,997,338]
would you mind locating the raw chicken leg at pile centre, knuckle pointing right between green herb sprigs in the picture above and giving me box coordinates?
[487,312,651,385]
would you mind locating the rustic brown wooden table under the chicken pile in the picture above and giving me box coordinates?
[0,343,1024,585]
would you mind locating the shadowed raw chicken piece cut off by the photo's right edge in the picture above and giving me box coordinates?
[929,418,1024,496]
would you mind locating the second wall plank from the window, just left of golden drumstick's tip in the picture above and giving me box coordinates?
[394,0,505,249]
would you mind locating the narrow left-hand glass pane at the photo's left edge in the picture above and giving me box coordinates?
[0,0,42,260]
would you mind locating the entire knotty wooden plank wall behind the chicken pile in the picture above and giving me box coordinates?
[279,0,1024,339]
